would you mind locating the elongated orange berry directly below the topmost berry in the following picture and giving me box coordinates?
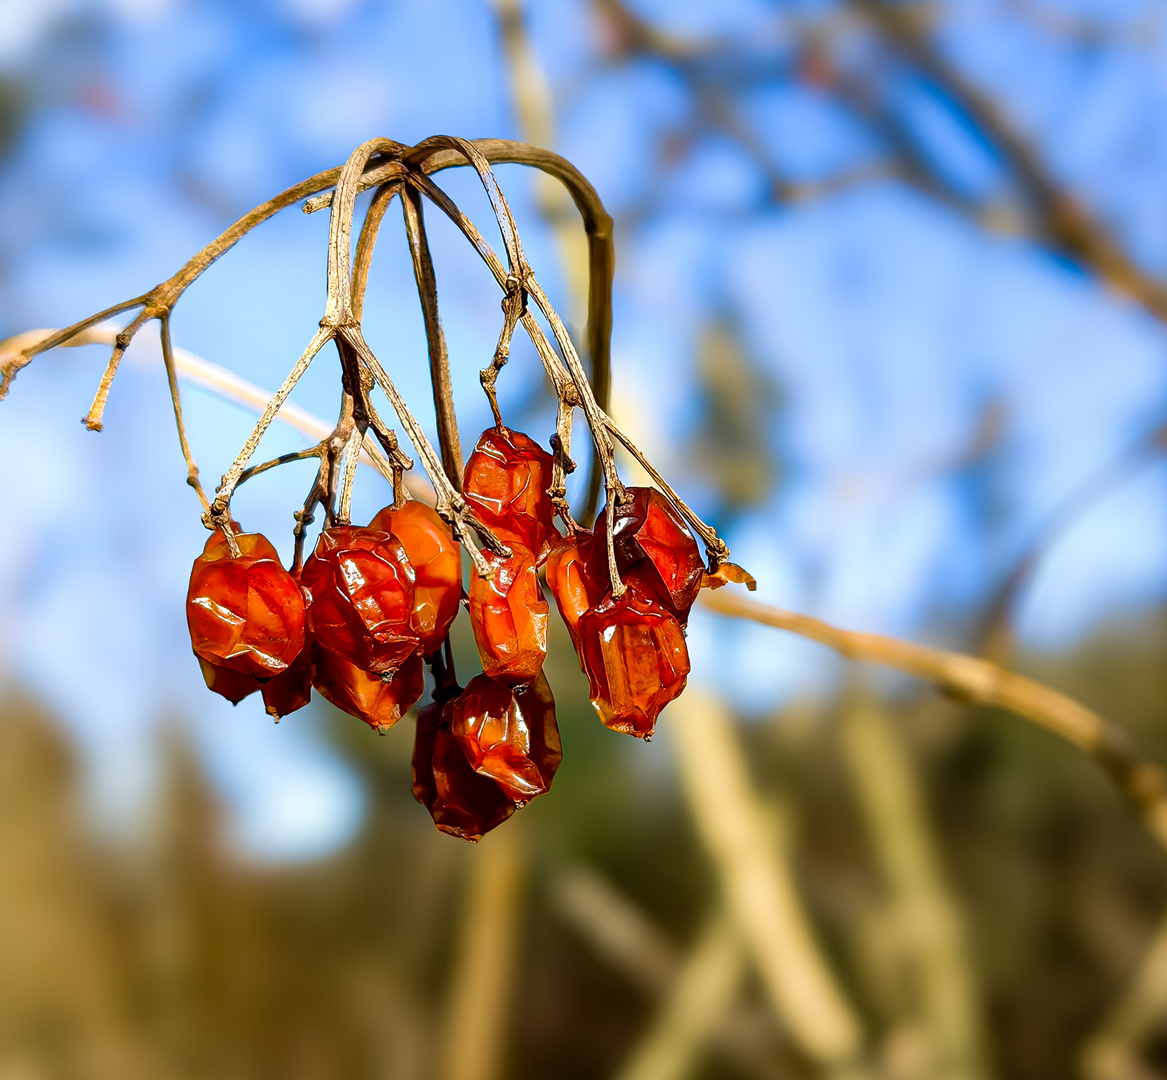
[470,544,550,683]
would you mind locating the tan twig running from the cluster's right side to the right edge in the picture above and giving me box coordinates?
[703,590,1167,849]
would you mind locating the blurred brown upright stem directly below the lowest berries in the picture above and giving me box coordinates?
[440,828,525,1080]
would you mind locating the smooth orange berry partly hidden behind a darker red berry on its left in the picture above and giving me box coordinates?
[369,500,462,656]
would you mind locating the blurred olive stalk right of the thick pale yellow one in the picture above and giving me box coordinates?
[840,696,988,1080]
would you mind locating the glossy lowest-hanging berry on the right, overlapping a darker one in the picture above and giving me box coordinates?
[450,675,564,803]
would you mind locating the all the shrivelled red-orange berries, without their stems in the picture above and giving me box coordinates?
[187,417,728,839]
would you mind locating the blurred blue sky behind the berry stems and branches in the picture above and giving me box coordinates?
[0,0,1167,859]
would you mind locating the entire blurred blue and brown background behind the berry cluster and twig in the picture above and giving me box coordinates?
[0,0,1167,1080]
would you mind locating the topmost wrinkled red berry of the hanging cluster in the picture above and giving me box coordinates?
[462,427,555,562]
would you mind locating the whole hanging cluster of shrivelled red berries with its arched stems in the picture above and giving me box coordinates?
[0,135,752,838]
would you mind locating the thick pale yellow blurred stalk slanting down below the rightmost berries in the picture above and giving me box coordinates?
[669,687,869,1080]
